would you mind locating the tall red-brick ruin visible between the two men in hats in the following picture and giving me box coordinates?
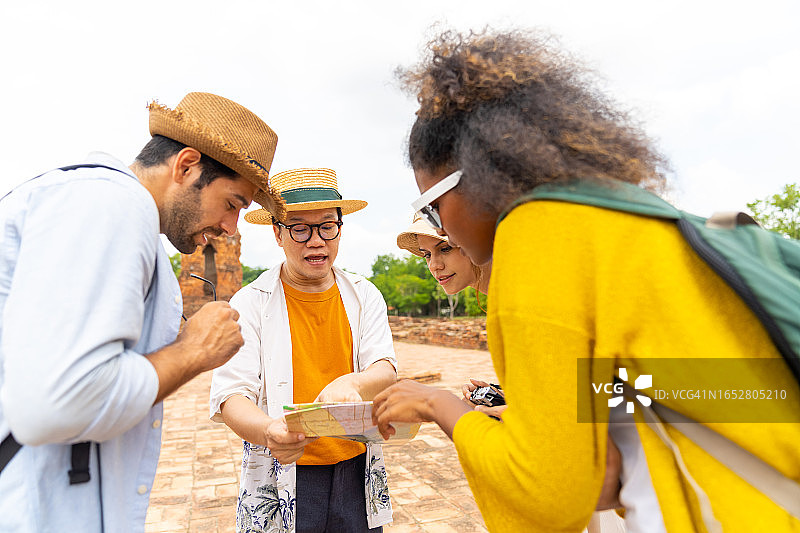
[178,231,242,317]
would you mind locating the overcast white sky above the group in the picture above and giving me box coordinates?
[0,0,800,275]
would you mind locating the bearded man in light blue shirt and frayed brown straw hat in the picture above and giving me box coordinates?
[0,93,281,532]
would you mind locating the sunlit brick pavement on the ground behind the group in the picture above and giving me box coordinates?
[145,342,495,533]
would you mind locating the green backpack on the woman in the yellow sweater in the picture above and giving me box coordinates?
[498,180,800,383]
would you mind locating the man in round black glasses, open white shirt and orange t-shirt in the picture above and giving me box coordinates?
[211,168,397,533]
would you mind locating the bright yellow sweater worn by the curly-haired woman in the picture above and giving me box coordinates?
[453,201,800,533]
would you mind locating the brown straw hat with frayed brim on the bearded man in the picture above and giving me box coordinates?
[149,93,283,217]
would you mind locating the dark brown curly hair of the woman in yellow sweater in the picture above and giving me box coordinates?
[398,30,668,214]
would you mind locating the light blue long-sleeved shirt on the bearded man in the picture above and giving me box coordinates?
[0,153,182,532]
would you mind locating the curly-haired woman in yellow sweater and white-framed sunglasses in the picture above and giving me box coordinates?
[373,32,800,532]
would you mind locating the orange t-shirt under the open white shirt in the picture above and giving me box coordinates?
[283,283,366,465]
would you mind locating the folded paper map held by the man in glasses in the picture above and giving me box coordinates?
[283,402,420,444]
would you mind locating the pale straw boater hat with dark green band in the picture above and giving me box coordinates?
[244,168,367,224]
